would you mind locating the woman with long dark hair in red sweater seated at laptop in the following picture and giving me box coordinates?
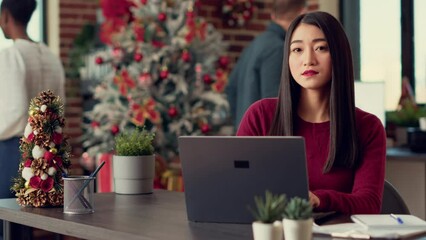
[237,12,386,214]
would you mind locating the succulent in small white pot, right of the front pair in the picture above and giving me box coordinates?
[283,197,313,240]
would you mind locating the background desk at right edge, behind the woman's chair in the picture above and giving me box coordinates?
[386,148,426,219]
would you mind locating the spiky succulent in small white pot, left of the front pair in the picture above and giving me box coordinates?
[249,191,287,240]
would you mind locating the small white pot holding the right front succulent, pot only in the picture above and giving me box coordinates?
[283,218,314,240]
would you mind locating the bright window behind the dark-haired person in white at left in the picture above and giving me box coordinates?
[0,0,45,49]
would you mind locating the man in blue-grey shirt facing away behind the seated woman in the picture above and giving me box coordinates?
[226,0,306,130]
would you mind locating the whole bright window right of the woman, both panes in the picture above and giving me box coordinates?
[356,0,426,111]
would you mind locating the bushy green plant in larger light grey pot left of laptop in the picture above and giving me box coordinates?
[113,127,155,194]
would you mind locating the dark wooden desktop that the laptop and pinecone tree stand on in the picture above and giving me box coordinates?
[0,190,424,240]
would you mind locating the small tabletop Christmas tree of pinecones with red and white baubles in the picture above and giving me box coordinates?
[12,90,70,207]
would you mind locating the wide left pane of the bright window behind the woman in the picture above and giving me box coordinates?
[360,0,401,110]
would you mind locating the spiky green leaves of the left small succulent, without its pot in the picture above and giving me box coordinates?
[249,190,287,223]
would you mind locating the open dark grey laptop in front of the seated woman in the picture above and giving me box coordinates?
[178,136,308,223]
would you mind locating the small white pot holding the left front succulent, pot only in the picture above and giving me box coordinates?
[252,221,283,240]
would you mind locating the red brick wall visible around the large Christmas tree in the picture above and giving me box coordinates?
[60,0,318,172]
